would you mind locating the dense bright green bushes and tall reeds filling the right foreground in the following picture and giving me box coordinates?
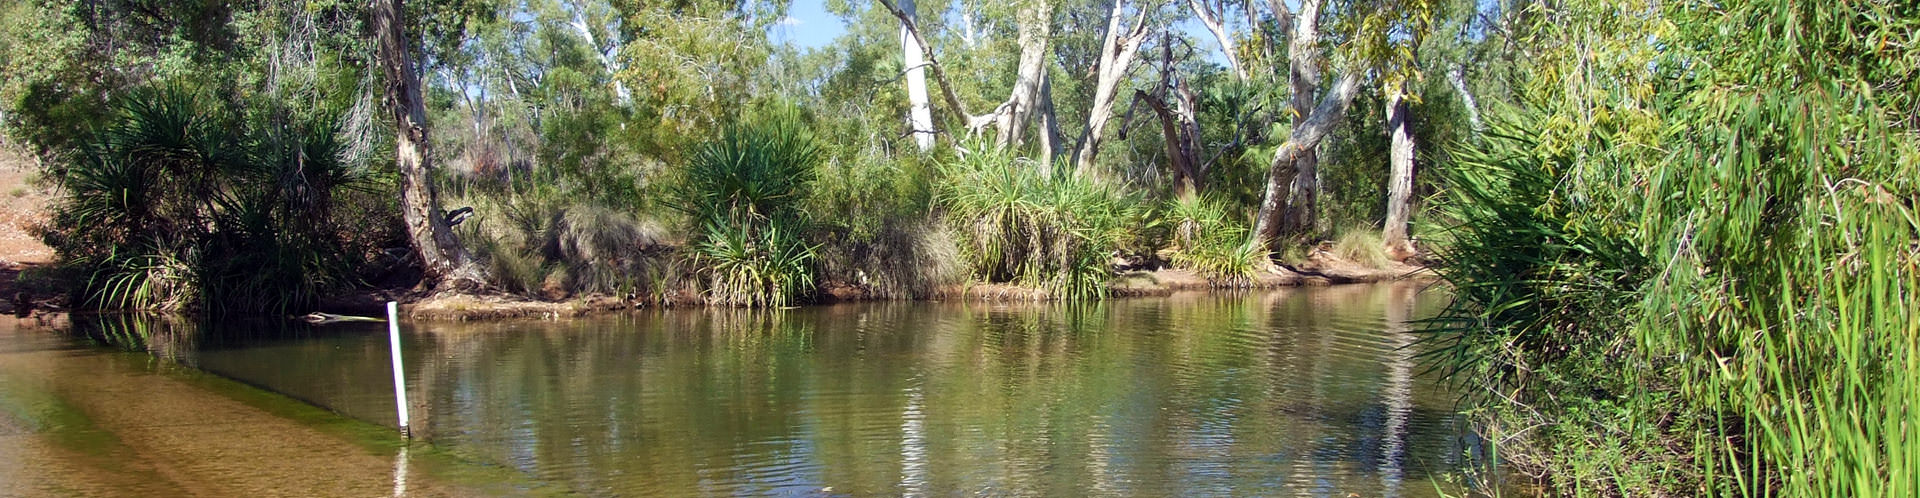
[1428,2,1920,496]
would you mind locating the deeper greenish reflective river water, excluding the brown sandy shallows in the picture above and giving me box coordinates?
[52,285,1480,496]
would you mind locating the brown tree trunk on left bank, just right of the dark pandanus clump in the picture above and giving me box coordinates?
[372,0,486,290]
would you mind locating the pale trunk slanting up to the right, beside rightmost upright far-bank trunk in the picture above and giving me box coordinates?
[1254,71,1359,248]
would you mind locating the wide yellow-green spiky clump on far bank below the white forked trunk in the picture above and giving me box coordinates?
[937,152,1146,300]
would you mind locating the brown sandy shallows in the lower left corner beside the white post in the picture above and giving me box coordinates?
[0,321,493,496]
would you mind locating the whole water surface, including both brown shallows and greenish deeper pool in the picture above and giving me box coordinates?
[0,285,1480,496]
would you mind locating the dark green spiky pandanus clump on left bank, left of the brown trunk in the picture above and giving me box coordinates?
[44,87,382,313]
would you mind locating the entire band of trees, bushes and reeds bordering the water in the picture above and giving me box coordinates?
[0,0,1920,496]
